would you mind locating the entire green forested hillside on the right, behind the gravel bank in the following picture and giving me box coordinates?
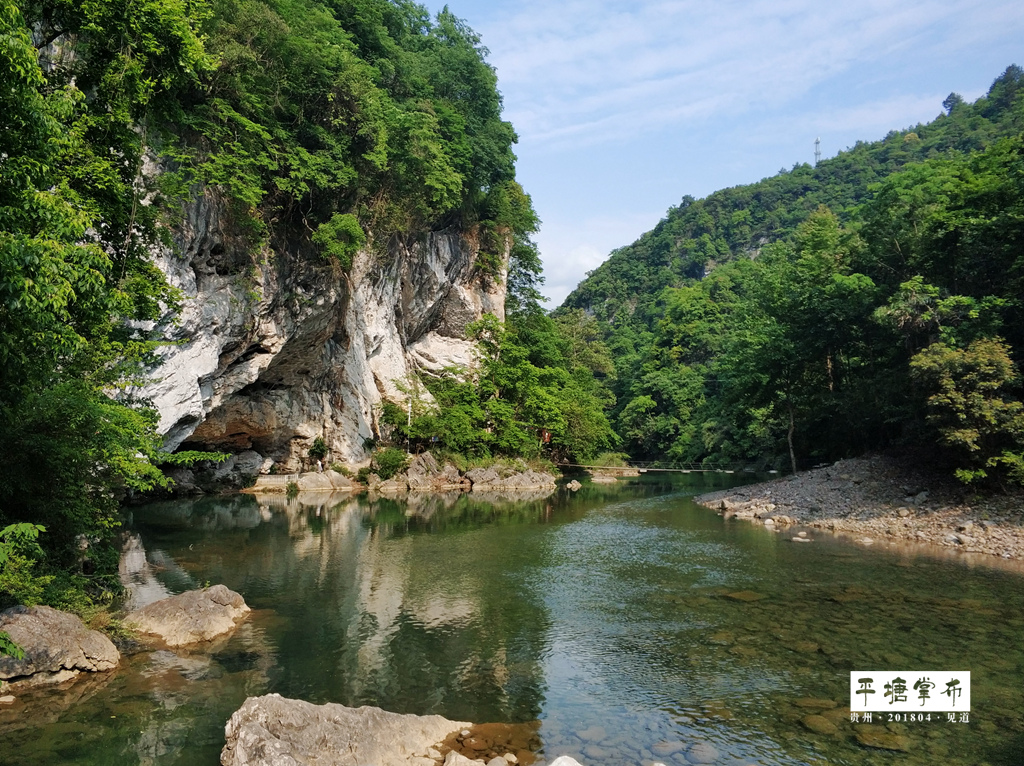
[556,66,1024,482]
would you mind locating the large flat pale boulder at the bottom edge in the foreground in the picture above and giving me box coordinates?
[220,694,471,766]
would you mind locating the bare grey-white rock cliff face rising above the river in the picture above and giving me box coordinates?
[141,193,507,473]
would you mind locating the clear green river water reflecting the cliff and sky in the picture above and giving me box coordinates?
[0,474,1024,766]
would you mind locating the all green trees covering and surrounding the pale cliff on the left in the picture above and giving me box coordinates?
[0,0,614,622]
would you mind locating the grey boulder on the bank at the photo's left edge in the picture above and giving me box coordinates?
[0,606,121,689]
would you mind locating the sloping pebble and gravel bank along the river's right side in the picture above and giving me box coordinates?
[694,456,1024,560]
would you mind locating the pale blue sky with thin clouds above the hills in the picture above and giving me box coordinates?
[426,0,1024,305]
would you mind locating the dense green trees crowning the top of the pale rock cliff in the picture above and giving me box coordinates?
[159,0,536,256]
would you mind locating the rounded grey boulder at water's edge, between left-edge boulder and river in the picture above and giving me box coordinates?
[125,585,250,646]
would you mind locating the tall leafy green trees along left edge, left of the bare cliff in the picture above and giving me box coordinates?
[0,0,206,607]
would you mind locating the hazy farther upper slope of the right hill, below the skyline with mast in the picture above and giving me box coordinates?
[562,66,1024,326]
